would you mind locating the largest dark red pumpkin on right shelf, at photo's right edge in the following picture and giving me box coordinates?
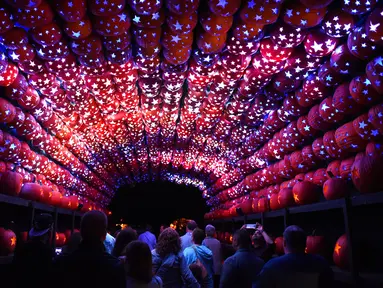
[351,155,383,193]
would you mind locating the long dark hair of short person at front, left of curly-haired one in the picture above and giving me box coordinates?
[125,241,152,283]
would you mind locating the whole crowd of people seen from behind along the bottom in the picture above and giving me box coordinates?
[9,211,333,288]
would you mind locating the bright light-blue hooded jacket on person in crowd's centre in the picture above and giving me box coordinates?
[184,245,214,288]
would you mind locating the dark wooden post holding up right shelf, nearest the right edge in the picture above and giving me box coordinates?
[343,197,359,287]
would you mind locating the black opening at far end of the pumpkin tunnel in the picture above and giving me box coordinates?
[109,182,209,231]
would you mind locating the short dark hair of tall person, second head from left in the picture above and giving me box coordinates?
[80,210,108,242]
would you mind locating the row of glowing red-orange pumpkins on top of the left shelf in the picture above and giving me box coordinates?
[0,170,107,212]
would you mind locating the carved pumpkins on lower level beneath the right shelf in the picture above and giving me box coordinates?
[217,231,349,269]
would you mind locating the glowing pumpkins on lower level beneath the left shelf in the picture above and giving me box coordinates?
[0,227,79,256]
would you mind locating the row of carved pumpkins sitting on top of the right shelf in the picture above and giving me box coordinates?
[205,142,383,219]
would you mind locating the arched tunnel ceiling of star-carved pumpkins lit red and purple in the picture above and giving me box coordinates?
[0,0,383,214]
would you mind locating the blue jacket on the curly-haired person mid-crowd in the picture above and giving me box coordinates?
[152,249,200,288]
